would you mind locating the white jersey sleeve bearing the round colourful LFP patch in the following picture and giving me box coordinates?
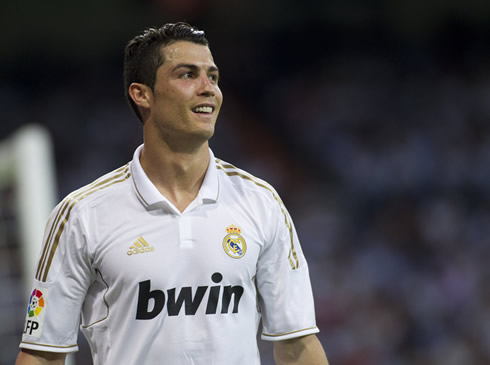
[20,200,93,352]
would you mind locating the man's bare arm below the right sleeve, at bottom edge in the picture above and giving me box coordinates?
[274,335,328,365]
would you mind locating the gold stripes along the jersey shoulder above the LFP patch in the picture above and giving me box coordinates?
[36,164,131,281]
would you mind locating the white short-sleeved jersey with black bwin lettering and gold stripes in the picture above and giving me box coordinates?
[20,146,318,365]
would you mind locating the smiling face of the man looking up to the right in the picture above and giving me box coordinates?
[147,41,223,143]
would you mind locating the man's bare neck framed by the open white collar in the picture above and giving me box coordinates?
[140,134,209,212]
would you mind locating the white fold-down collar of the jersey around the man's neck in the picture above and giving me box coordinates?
[131,145,219,210]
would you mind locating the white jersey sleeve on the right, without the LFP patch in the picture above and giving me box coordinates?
[256,201,319,341]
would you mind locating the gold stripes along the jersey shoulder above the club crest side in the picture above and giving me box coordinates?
[215,158,299,270]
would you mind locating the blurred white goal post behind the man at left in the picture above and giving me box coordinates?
[0,124,57,298]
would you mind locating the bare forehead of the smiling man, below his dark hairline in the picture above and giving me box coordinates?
[161,41,214,66]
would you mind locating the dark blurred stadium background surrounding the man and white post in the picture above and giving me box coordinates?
[0,0,490,365]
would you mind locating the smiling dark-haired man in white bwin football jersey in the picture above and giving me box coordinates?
[17,23,328,365]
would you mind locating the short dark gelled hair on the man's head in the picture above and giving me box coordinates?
[123,22,209,122]
